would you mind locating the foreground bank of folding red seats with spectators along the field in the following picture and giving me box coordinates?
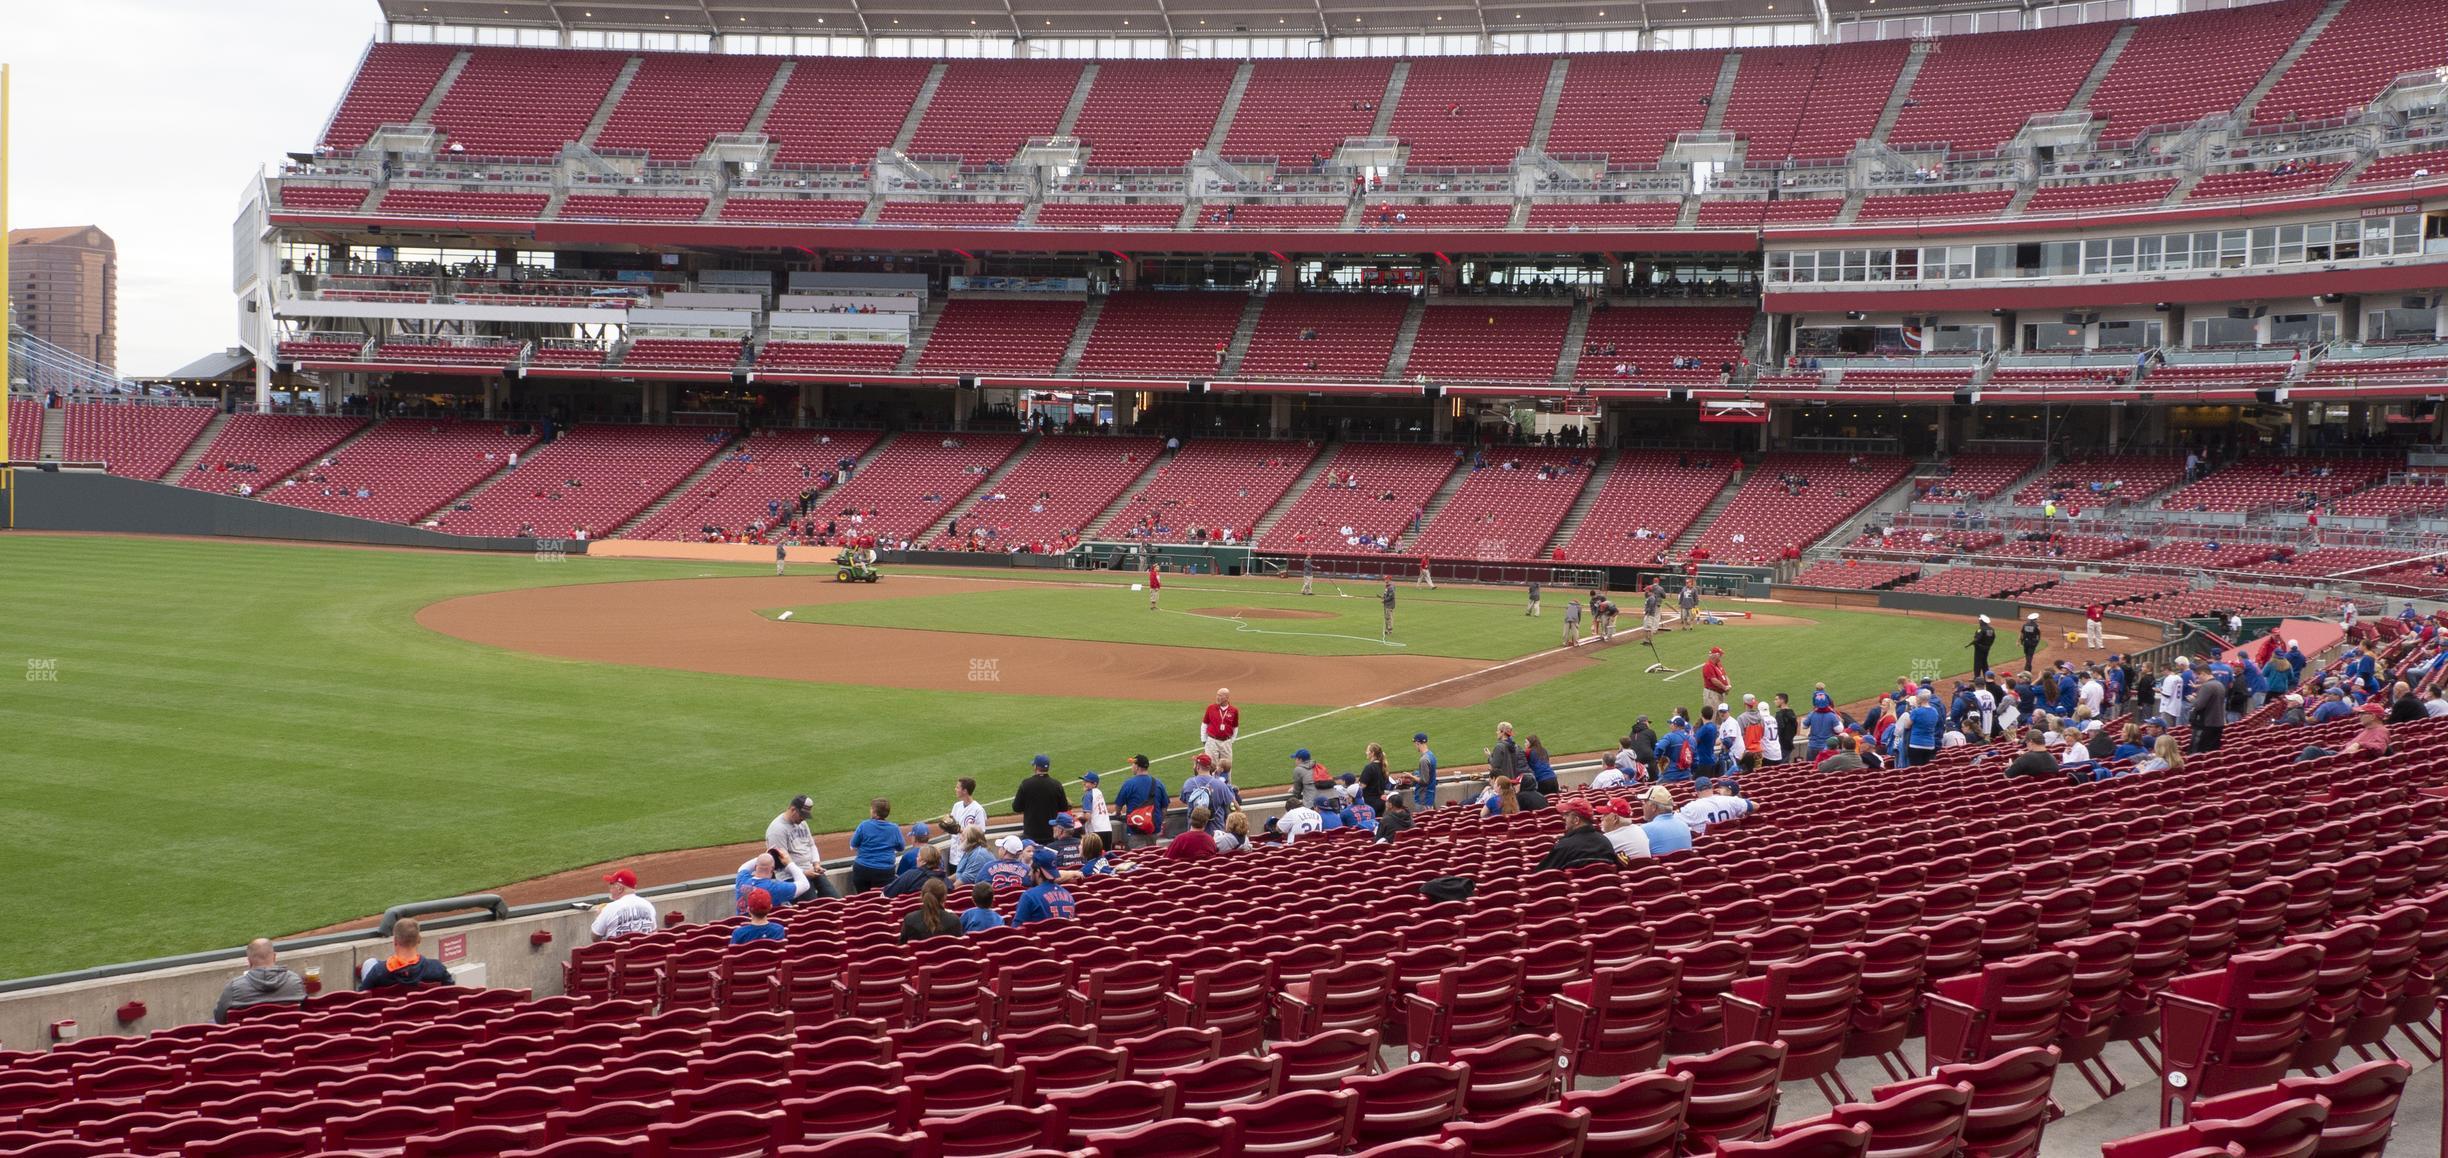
[0,592,2448,1158]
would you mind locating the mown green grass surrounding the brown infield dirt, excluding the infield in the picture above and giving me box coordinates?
[0,534,1963,977]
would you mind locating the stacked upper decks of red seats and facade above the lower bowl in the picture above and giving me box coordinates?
[233,0,2448,426]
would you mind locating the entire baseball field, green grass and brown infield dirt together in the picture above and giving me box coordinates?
[0,534,1963,977]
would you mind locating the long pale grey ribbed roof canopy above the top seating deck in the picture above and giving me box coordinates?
[362,0,2029,39]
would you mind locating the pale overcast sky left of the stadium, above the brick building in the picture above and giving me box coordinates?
[0,0,382,375]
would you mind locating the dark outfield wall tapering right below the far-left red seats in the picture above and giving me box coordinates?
[12,468,560,553]
